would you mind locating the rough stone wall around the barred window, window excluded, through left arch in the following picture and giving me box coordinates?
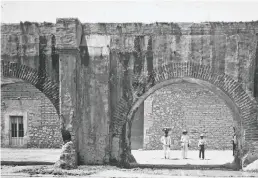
[1,82,63,148]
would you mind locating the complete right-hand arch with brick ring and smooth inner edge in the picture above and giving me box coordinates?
[111,62,258,169]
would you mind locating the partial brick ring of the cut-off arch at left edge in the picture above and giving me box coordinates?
[1,60,60,114]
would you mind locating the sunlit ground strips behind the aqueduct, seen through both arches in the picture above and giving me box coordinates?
[1,148,233,165]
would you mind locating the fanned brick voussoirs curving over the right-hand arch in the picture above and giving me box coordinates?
[115,62,258,142]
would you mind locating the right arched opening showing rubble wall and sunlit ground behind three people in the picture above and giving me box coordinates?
[131,78,239,165]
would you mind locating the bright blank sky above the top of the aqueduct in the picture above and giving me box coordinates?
[1,0,258,23]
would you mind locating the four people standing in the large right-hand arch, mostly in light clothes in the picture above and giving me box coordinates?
[160,128,236,159]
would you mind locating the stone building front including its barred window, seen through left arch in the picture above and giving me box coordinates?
[1,77,63,148]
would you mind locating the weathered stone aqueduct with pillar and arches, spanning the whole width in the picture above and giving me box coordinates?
[1,19,258,166]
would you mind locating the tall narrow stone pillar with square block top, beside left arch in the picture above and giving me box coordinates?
[56,18,82,165]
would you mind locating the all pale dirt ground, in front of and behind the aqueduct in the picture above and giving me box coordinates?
[1,148,258,178]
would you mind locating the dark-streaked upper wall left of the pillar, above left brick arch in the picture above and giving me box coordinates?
[1,22,59,81]
